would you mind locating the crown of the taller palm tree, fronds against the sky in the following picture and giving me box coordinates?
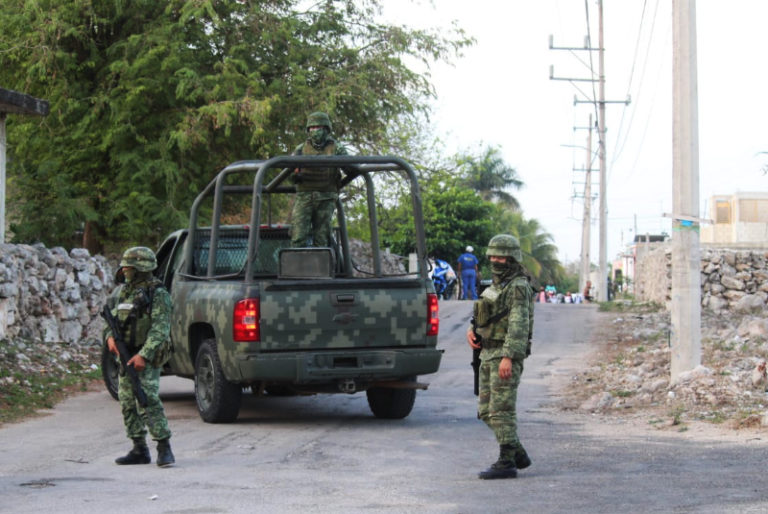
[459,147,523,210]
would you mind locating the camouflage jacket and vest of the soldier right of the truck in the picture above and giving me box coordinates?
[474,274,533,361]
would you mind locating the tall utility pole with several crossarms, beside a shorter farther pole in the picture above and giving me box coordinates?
[549,0,630,301]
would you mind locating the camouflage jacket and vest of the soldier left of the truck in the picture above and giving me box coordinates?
[105,282,171,368]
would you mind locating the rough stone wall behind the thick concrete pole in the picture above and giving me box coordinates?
[635,245,768,313]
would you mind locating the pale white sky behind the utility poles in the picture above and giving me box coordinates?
[385,0,768,263]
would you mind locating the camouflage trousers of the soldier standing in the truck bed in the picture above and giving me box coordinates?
[291,191,339,247]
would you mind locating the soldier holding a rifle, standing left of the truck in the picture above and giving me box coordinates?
[106,246,175,467]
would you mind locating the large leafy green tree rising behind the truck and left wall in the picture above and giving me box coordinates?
[0,0,471,250]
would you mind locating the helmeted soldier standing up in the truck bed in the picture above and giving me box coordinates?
[291,112,347,247]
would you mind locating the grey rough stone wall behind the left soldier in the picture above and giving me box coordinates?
[0,244,114,344]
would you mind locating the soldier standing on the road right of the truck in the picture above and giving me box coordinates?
[467,234,533,479]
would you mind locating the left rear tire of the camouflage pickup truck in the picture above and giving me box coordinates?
[195,339,243,423]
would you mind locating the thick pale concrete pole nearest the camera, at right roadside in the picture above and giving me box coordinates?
[671,0,702,376]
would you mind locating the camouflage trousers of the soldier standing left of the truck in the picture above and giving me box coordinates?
[117,366,171,441]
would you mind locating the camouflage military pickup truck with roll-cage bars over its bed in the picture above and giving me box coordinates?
[100,156,442,423]
